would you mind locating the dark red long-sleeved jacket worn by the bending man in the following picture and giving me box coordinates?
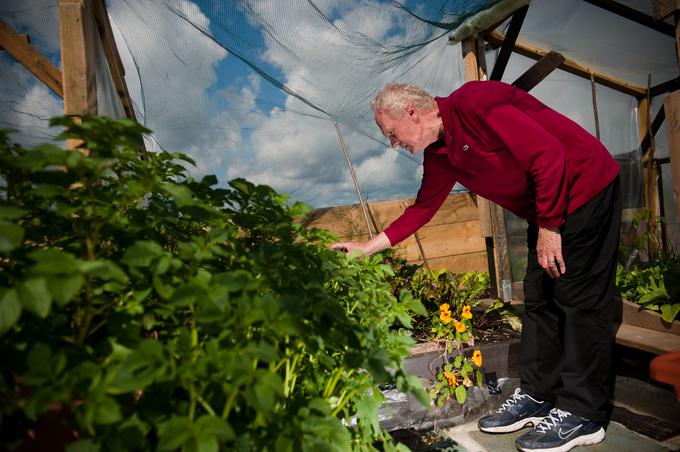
[384,81,619,245]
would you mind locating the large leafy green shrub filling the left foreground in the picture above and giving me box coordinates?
[0,117,427,451]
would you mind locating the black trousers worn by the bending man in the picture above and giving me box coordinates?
[520,177,621,422]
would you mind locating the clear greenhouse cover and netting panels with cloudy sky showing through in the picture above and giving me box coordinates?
[0,0,678,214]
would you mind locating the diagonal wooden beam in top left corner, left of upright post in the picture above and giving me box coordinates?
[0,19,64,98]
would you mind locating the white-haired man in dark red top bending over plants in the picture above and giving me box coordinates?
[333,81,621,451]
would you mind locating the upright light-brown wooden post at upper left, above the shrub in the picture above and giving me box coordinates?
[59,0,97,115]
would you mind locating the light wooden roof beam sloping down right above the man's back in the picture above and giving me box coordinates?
[485,31,647,98]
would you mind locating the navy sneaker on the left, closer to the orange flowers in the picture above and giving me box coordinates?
[477,388,552,433]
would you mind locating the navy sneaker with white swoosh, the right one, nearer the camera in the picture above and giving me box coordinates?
[515,408,605,452]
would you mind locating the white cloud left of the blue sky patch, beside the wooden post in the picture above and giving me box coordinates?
[109,0,227,150]
